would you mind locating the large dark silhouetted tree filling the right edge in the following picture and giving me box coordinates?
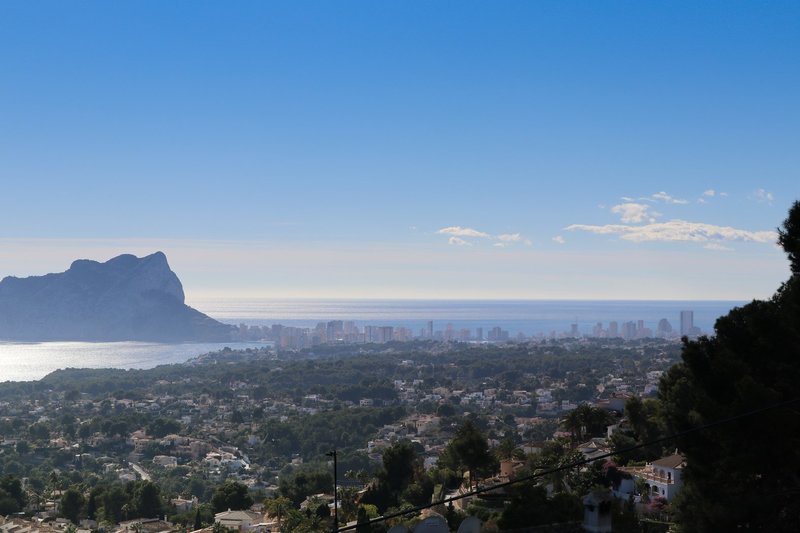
[659,202,800,533]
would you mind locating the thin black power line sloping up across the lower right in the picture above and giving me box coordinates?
[336,398,800,532]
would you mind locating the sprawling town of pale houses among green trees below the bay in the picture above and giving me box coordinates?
[0,338,683,533]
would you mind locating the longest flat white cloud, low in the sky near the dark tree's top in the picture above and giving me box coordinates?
[566,220,777,243]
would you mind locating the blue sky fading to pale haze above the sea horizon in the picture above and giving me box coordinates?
[0,0,800,302]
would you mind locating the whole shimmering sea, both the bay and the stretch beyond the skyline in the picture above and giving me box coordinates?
[0,298,745,382]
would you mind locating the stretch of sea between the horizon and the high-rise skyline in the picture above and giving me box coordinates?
[190,299,745,336]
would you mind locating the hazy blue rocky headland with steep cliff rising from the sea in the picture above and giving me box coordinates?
[0,252,232,342]
